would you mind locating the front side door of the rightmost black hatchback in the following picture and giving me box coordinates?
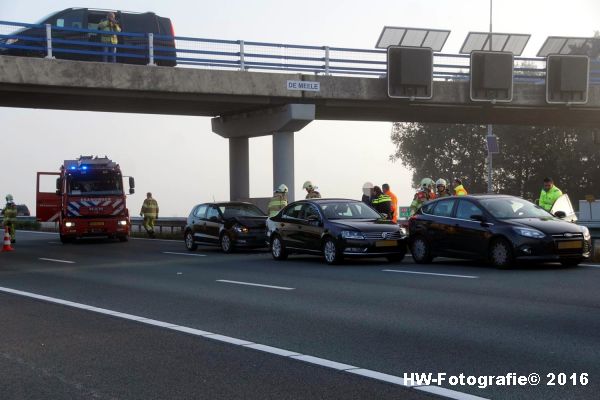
[448,199,491,257]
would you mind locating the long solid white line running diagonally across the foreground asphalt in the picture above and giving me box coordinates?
[0,287,488,400]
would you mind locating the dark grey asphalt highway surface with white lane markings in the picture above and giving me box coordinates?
[0,232,600,400]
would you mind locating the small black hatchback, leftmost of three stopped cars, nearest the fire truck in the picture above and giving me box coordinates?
[184,202,267,253]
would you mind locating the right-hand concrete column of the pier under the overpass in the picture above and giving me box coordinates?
[273,132,295,203]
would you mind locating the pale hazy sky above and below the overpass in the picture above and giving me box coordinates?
[0,0,600,216]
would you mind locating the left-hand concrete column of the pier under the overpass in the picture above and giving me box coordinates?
[229,137,250,200]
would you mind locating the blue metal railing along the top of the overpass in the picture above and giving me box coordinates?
[0,21,600,84]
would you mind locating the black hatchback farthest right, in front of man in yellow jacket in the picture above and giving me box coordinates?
[409,195,591,267]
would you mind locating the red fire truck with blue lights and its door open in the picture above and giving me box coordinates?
[36,156,135,243]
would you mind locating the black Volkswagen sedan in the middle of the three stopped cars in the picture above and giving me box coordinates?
[267,199,407,264]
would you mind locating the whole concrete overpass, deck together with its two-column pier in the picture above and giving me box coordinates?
[0,20,600,199]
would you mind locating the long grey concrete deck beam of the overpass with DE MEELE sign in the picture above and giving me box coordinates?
[0,56,600,126]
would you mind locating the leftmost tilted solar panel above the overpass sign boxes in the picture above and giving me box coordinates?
[375,26,450,51]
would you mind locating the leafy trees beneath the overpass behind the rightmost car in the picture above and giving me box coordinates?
[390,123,600,206]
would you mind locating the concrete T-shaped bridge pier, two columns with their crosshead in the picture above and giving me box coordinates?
[211,104,315,201]
